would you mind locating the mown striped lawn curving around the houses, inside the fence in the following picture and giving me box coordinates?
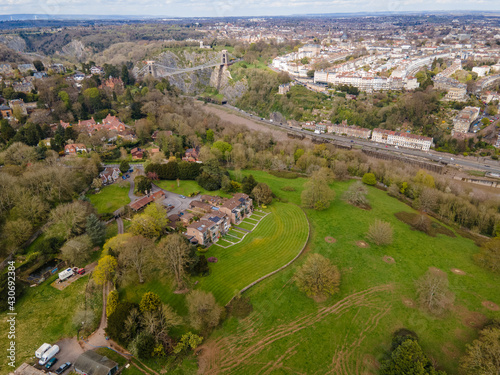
[120,203,308,314]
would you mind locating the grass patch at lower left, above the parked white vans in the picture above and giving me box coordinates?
[0,275,88,373]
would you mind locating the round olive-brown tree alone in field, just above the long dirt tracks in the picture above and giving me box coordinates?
[294,254,340,298]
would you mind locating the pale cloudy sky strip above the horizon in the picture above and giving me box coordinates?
[0,0,500,17]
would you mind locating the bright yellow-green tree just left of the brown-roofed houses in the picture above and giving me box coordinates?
[130,203,168,238]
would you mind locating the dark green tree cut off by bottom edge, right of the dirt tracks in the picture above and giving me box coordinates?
[379,337,445,375]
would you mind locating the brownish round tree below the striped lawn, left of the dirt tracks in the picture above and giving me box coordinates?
[186,290,223,330]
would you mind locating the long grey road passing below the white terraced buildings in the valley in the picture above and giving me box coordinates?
[223,104,500,174]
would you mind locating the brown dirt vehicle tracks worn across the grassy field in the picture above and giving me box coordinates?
[199,285,392,375]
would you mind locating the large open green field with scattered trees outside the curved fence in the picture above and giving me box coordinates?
[194,171,500,374]
